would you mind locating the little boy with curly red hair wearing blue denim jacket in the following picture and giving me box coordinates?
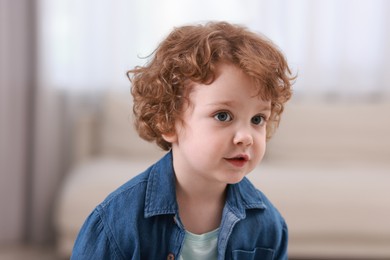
[72,22,293,260]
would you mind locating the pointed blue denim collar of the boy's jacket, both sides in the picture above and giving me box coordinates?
[145,152,266,219]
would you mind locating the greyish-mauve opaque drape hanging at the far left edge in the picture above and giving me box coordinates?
[0,0,35,244]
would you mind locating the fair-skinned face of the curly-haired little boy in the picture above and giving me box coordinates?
[164,64,271,187]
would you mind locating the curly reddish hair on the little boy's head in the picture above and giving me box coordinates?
[127,22,295,150]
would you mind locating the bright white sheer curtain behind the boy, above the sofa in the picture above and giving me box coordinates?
[39,0,390,97]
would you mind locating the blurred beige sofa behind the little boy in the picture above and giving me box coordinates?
[54,93,390,259]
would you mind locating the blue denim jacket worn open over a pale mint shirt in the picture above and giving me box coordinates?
[71,153,288,260]
